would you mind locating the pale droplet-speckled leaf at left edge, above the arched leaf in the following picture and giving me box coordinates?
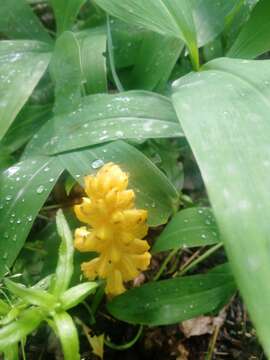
[0,40,50,140]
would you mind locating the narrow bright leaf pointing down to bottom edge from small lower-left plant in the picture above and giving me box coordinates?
[53,312,80,360]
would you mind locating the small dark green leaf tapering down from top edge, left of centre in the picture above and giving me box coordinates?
[50,0,86,36]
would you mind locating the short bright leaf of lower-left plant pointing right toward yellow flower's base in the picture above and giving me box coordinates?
[59,282,98,310]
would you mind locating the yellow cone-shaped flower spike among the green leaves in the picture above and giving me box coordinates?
[74,163,151,296]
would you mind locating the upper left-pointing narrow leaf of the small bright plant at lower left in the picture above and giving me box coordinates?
[4,279,56,311]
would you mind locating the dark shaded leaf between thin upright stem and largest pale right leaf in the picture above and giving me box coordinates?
[131,32,184,91]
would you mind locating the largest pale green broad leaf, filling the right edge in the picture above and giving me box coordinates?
[173,59,270,355]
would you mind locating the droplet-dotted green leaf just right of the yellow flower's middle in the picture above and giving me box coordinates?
[152,207,220,253]
